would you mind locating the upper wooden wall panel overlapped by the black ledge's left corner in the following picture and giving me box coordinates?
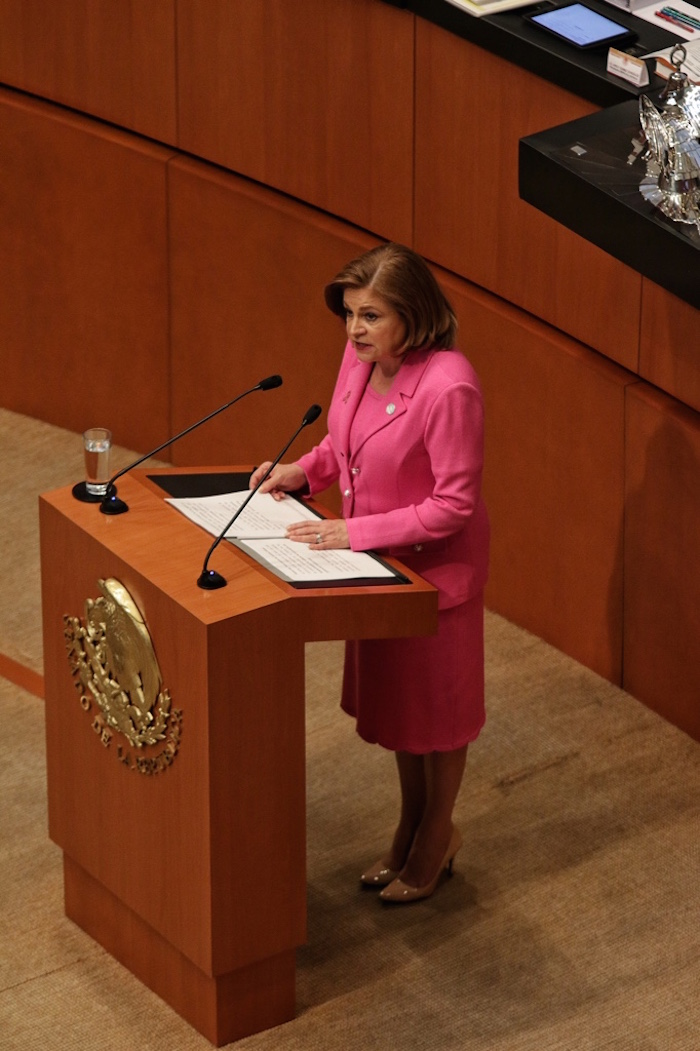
[414,20,641,370]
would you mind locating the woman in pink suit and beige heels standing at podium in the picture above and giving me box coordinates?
[250,244,489,902]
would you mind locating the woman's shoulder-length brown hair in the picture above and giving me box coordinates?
[324,242,457,350]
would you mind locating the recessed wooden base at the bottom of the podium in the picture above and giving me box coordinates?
[63,854,296,1047]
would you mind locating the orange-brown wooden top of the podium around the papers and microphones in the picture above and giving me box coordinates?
[40,467,437,641]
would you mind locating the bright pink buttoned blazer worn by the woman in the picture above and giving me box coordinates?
[297,343,489,609]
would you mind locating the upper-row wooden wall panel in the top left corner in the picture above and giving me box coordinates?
[0,0,176,143]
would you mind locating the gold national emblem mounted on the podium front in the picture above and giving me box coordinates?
[63,578,182,774]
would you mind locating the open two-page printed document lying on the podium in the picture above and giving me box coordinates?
[166,490,401,586]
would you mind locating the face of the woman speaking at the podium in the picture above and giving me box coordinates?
[343,288,406,371]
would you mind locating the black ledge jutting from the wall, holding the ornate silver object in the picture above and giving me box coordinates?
[519,102,700,308]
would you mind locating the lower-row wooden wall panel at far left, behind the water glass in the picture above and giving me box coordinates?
[0,90,169,452]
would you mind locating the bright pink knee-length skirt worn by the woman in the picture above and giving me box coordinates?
[341,594,486,755]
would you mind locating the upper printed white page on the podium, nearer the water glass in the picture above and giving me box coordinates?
[166,489,318,540]
